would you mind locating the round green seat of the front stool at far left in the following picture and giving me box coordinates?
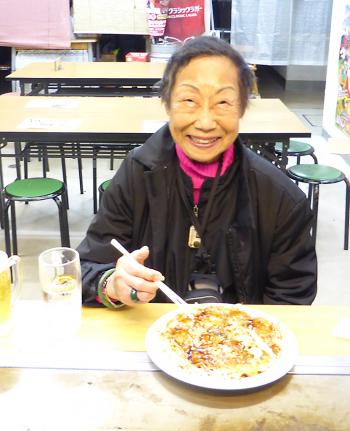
[5,178,63,200]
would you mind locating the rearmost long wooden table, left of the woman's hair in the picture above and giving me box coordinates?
[6,62,165,96]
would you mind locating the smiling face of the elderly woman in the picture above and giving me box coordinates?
[167,56,241,163]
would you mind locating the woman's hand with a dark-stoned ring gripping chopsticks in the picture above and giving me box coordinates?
[106,246,164,306]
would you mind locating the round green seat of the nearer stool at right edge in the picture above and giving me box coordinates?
[288,163,345,184]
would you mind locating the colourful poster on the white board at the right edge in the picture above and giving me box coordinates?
[335,2,350,136]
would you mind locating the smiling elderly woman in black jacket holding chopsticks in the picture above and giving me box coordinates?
[78,36,317,308]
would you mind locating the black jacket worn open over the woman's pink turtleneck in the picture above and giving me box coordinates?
[78,126,317,305]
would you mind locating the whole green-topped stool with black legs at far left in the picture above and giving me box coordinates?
[3,178,70,256]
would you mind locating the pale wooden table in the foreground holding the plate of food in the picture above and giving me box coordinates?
[0,301,350,431]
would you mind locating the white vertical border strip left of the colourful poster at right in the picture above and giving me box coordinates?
[322,0,349,138]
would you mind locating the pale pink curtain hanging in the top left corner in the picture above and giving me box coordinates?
[0,0,71,49]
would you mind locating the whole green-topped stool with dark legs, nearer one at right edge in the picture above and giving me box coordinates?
[287,164,350,250]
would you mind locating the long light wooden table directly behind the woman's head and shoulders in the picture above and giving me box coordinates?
[0,96,311,169]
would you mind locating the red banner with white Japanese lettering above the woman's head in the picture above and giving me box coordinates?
[164,0,205,41]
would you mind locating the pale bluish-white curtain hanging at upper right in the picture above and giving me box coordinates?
[231,0,332,66]
